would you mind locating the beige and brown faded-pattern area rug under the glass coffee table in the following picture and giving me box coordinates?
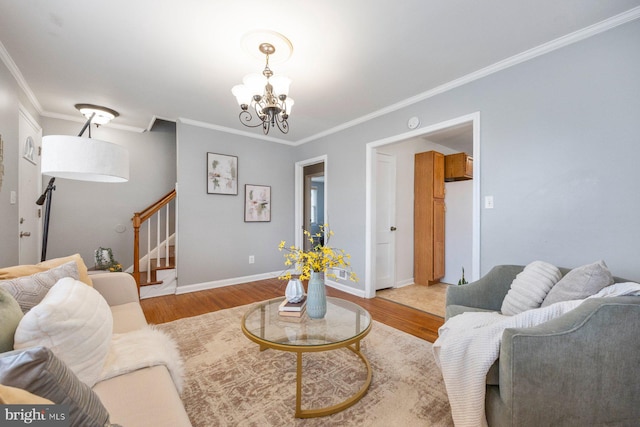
[157,306,453,427]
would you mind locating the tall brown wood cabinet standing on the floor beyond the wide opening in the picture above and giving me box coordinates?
[413,151,445,285]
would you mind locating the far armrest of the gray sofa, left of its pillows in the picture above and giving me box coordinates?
[445,265,524,320]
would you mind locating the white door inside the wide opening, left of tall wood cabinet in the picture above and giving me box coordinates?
[375,153,396,290]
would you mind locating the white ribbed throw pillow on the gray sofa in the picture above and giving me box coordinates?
[500,261,562,316]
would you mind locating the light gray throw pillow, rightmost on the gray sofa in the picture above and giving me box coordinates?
[542,260,614,307]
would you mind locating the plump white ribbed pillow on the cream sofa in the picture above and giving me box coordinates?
[14,277,113,387]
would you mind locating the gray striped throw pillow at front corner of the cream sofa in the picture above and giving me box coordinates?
[0,348,109,427]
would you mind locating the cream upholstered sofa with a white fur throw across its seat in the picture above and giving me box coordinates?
[91,273,191,427]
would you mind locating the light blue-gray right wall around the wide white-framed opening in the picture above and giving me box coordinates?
[288,17,640,288]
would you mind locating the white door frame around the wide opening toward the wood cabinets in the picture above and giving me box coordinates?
[364,112,481,298]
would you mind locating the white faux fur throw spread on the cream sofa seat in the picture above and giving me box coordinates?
[98,326,184,394]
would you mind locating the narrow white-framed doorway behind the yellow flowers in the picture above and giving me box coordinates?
[294,155,328,251]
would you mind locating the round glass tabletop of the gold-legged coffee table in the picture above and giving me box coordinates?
[242,297,371,347]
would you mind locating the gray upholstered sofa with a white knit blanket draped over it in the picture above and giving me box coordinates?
[445,265,640,427]
